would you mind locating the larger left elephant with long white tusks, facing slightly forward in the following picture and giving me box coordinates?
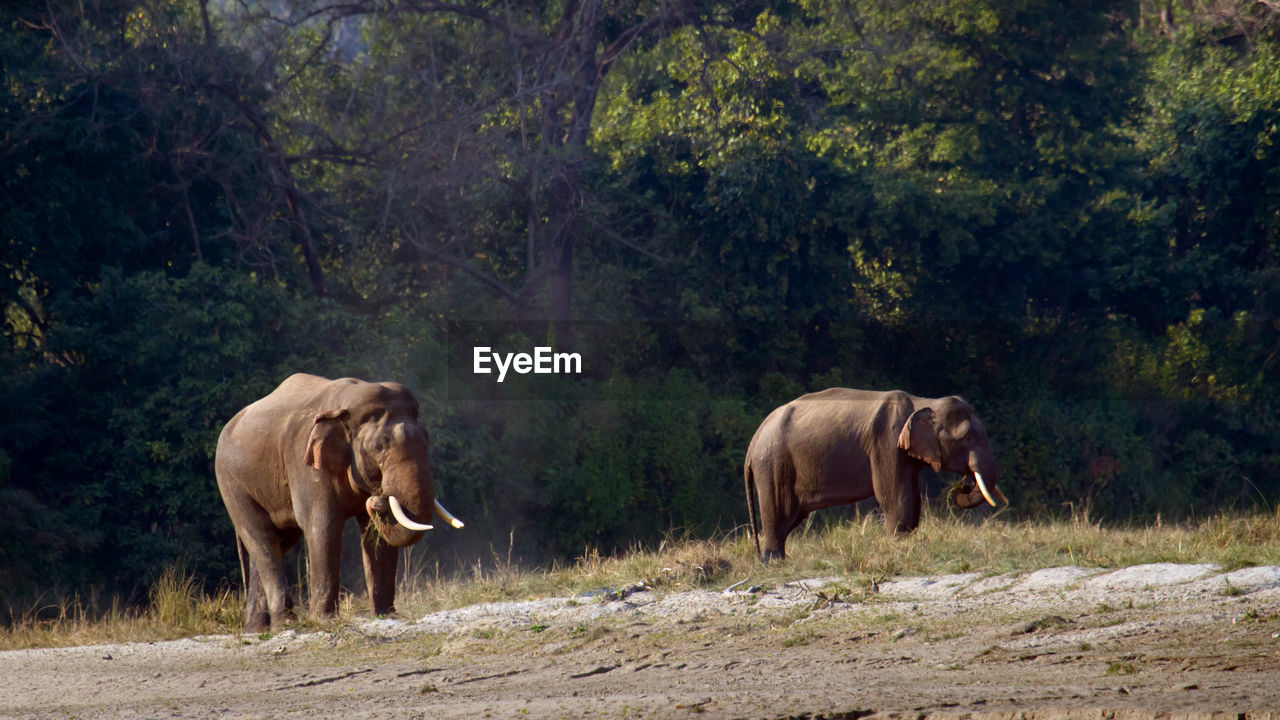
[214,373,463,633]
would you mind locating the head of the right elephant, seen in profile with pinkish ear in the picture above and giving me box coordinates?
[897,397,1009,507]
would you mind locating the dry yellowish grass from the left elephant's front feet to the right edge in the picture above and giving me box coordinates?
[397,510,1280,616]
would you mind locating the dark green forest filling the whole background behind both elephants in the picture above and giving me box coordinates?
[0,0,1280,611]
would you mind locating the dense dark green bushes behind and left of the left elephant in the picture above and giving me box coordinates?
[0,264,378,602]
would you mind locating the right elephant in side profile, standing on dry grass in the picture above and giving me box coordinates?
[742,387,1009,565]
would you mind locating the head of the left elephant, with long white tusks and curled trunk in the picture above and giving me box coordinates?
[305,383,462,547]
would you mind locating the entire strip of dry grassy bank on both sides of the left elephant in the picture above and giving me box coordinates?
[0,510,1280,650]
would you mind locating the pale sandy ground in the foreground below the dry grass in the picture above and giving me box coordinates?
[0,564,1280,720]
